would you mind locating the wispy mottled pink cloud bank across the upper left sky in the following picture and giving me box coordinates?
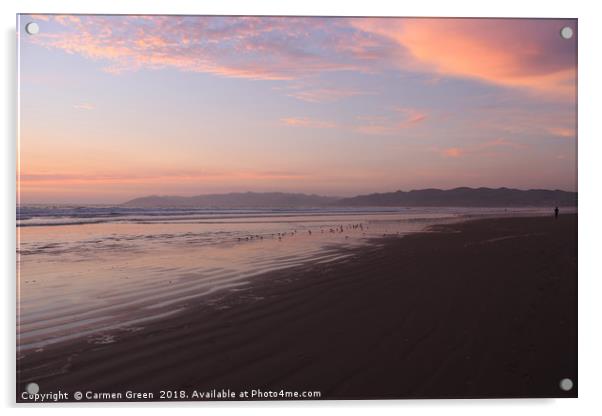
[31,15,384,82]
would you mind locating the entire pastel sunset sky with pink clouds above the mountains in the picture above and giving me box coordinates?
[17,15,577,203]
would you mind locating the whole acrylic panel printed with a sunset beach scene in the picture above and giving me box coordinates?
[16,14,577,402]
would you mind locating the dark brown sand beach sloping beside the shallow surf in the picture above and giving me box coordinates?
[17,215,577,401]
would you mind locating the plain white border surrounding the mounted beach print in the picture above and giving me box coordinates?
[0,0,602,416]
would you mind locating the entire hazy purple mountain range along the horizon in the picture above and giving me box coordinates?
[123,187,577,208]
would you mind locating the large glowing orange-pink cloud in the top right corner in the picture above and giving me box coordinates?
[352,18,576,97]
